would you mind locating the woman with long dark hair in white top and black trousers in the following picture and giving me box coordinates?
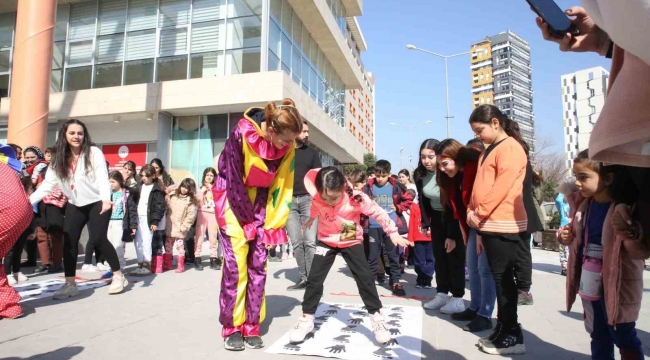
[30,119,128,300]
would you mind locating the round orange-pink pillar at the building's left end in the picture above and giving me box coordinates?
[7,0,57,149]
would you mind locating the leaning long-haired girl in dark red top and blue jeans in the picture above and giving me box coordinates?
[436,139,496,332]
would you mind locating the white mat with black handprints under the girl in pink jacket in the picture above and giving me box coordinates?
[266,303,422,360]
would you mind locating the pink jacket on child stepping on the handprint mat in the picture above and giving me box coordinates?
[305,169,397,248]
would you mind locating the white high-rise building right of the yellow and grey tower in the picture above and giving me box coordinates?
[561,66,609,170]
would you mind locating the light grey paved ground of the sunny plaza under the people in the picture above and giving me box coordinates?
[0,246,650,360]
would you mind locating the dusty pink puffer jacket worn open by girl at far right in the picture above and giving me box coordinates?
[566,193,650,326]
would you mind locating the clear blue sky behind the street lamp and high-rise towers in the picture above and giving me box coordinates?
[358,0,610,173]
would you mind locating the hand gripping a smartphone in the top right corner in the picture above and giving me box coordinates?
[527,5,609,55]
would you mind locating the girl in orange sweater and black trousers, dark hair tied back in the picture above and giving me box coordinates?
[467,105,531,355]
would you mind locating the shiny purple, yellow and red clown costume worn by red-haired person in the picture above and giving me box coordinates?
[212,108,295,338]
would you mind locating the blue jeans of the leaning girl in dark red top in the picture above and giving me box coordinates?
[465,229,497,318]
